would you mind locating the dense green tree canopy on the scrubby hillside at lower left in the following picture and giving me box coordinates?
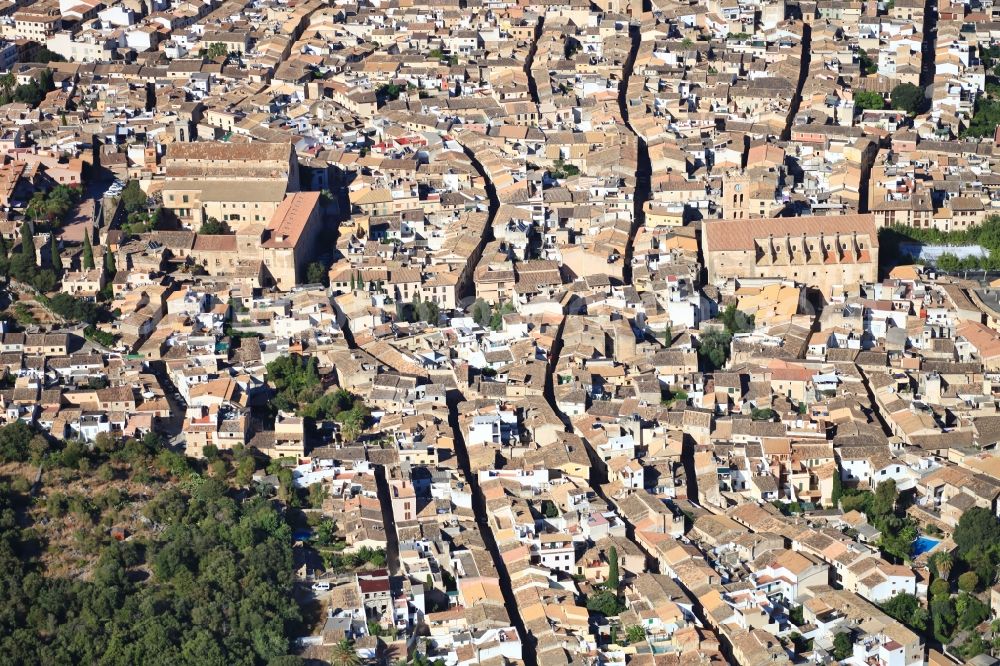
[0,448,301,666]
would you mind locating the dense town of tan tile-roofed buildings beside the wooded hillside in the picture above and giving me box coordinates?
[0,0,1000,666]
